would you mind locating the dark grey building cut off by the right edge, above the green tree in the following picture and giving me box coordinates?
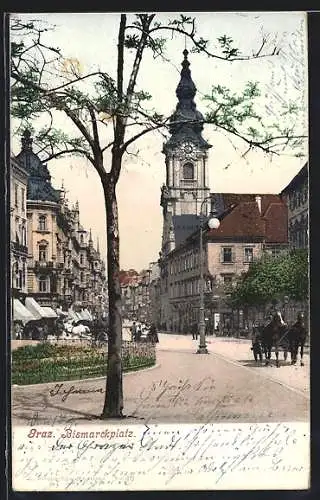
[281,163,309,248]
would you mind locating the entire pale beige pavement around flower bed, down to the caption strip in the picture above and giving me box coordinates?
[12,334,309,425]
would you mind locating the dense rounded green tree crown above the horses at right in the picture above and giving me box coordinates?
[231,249,309,306]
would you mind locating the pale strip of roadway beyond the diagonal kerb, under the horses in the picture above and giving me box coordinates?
[157,333,310,396]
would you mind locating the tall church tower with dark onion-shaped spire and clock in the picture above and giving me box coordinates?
[160,49,211,256]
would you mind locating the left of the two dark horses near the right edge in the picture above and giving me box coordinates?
[261,311,287,367]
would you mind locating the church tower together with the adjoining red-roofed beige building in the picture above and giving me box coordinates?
[159,50,287,332]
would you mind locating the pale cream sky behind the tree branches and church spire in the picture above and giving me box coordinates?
[12,12,307,271]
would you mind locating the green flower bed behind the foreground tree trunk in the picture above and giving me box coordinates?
[11,342,156,385]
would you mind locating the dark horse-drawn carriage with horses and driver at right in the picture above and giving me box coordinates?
[251,311,307,366]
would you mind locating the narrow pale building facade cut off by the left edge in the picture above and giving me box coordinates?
[10,158,28,300]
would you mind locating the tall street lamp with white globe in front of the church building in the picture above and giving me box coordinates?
[197,196,220,354]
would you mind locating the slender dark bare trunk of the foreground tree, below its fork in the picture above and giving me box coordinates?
[101,179,123,419]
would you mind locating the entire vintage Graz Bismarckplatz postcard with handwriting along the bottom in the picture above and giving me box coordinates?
[10,11,310,492]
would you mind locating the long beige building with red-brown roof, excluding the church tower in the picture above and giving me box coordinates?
[159,194,287,332]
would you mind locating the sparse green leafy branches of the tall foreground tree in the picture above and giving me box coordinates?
[11,14,303,161]
